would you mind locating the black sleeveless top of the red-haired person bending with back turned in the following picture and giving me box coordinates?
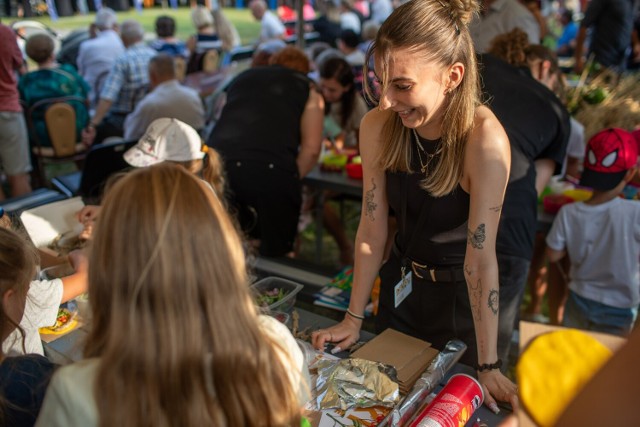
[207,65,311,172]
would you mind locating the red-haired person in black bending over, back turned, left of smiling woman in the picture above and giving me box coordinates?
[207,47,324,256]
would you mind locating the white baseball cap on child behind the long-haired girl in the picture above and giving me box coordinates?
[124,118,204,168]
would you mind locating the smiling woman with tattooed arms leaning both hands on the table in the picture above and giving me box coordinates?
[313,0,517,412]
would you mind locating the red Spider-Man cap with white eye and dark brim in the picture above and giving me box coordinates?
[580,128,638,191]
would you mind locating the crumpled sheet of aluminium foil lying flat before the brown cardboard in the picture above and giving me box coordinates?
[316,359,400,410]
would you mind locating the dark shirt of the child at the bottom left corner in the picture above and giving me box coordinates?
[0,354,55,427]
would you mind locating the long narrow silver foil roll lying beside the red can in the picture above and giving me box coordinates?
[380,340,467,427]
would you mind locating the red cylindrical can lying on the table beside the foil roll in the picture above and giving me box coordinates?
[410,374,484,427]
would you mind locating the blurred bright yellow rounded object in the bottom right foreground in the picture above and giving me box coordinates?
[516,329,611,427]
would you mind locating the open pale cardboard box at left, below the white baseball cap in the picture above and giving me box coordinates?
[20,197,84,258]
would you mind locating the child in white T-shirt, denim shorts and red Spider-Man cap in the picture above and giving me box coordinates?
[547,129,640,335]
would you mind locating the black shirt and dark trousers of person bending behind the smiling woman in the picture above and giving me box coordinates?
[478,54,570,259]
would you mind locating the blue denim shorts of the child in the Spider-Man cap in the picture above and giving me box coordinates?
[563,291,638,336]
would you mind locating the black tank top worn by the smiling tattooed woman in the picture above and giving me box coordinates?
[386,132,469,267]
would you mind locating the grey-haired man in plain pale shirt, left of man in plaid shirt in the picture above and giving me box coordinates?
[77,7,124,107]
